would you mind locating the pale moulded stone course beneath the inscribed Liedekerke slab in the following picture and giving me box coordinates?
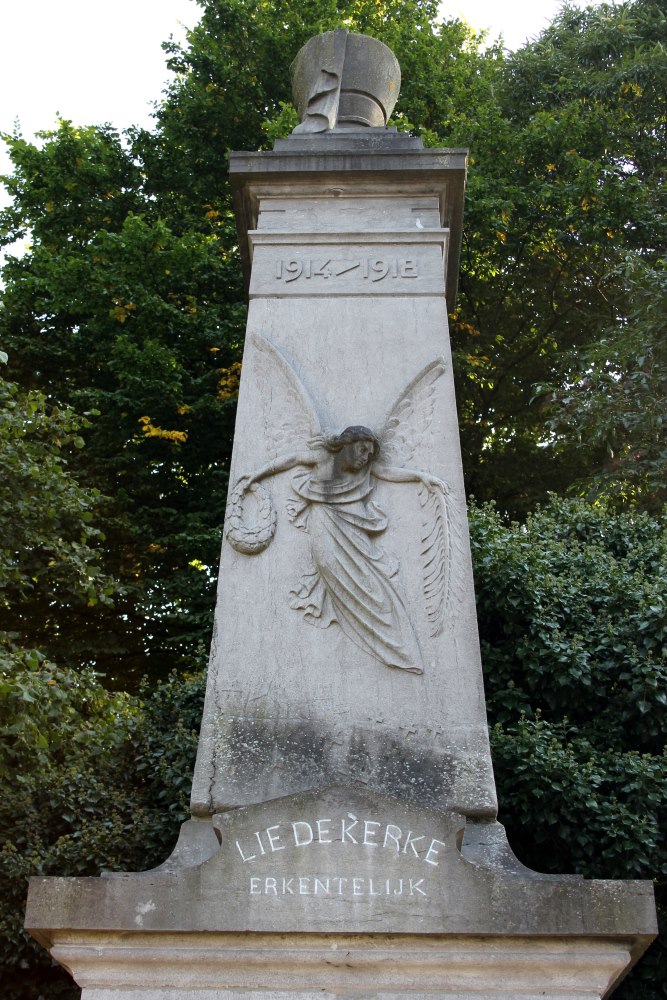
[35,932,633,1000]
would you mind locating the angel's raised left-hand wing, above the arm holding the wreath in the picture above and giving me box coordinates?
[251,333,321,458]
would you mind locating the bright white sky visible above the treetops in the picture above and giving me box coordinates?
[0,0,596,188]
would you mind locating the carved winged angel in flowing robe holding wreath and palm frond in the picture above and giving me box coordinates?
[226,336,460,674]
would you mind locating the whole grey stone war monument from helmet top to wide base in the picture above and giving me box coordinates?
[26,31,655,1000]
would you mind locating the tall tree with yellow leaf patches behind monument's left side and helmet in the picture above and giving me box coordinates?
[0,0,500,685]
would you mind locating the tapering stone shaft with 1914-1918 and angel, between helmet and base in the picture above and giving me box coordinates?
[192,145,496,816]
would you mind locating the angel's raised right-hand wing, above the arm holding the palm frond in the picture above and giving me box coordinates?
[380,358,445,466]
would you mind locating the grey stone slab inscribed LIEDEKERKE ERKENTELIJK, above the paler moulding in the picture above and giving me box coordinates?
[26,788,654,939]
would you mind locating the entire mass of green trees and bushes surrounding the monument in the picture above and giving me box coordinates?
[0,0,667,1000]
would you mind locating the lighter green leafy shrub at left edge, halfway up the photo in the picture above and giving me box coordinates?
[0,360,117,668]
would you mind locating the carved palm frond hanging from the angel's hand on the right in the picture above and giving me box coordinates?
[419,486,462,636]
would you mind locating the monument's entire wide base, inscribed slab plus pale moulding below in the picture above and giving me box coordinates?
[26,788,656,1000]
